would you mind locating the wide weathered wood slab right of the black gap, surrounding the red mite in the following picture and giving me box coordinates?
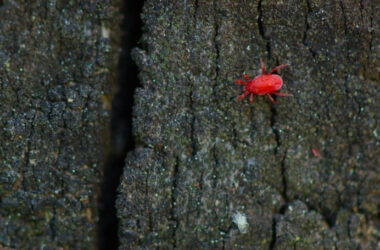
[117,0,380,249]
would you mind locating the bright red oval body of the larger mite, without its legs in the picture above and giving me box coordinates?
[247,75,282,95]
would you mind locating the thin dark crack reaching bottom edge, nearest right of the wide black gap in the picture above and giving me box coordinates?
[169,158,179,249]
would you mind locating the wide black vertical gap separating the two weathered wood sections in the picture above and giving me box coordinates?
[98,0,144,250]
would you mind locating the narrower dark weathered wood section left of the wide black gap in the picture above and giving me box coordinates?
[0,0,119,249]
